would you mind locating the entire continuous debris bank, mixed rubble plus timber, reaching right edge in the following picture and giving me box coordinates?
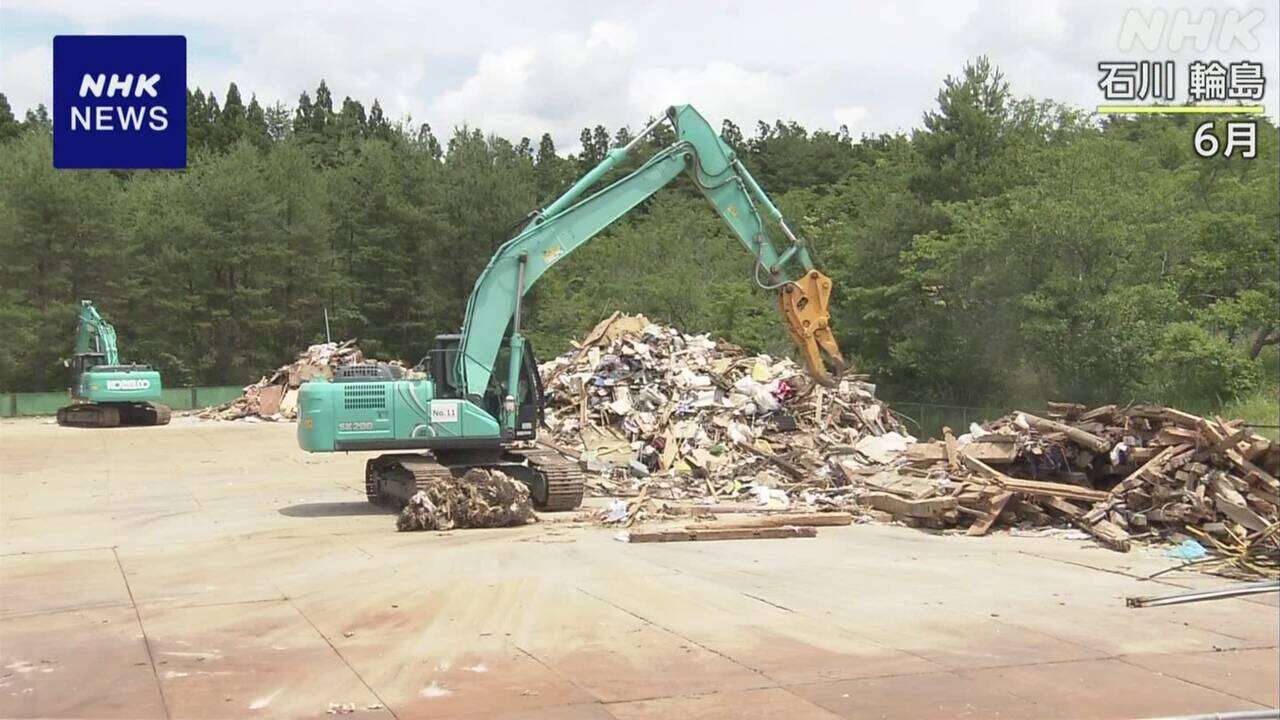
[540,314,1280,577]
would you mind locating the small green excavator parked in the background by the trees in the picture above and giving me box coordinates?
[58,300,170,428]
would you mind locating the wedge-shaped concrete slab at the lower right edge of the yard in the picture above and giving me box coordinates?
[1120,648,1280,707]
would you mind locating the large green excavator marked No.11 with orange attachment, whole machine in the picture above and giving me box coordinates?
[297,105,845,510]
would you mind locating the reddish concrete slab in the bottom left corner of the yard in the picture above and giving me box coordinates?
[0,602,165,719]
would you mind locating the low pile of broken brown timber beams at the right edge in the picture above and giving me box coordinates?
[870,402,1280,574]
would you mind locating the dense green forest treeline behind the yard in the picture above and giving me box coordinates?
[0,59,1280,405]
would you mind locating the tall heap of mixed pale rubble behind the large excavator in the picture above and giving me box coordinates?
[539,313,914,512]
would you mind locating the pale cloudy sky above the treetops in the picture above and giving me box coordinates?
[0,0,1280,151]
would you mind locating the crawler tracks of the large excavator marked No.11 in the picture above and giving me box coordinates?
[365,450,585,511]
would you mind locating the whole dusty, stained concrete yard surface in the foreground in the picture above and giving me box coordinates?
[0,419,1280,719]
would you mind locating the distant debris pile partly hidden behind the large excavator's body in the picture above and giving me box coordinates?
[197,340,414,420]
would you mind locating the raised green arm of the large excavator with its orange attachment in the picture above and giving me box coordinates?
[456,105,845,415]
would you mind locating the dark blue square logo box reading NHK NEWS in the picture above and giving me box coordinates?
[54,35,187,169]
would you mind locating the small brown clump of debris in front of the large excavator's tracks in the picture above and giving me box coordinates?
[396,468,534,530]
